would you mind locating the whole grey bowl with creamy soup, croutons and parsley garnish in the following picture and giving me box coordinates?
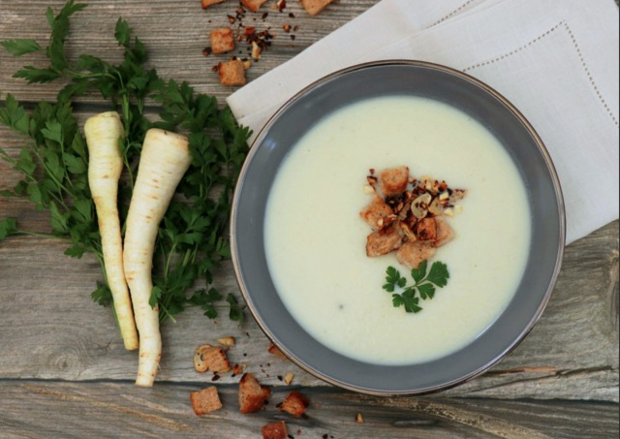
[231,61,565,395]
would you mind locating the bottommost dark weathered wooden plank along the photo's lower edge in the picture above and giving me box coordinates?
[0,381,618,439]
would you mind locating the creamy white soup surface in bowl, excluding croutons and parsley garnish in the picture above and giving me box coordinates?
[264,97,531,365]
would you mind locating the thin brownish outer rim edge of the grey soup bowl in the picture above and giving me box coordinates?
[230,59,566,396]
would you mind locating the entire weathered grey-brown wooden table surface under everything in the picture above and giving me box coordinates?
[0,0,619,439]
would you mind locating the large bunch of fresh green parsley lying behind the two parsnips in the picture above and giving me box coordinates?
[0,0,250,322]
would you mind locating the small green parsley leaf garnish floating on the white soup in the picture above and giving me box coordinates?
[383,261,450,314]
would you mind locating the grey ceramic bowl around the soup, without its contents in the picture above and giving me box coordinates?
[231,61,565,395]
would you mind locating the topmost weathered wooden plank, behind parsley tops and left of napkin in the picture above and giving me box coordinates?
[0,0,379,102]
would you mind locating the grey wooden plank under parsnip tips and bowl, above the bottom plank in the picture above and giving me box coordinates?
[0,215,618,401]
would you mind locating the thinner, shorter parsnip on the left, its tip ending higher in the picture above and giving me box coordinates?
[84,112,138,350]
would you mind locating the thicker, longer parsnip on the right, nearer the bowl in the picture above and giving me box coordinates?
[124,129,192,387]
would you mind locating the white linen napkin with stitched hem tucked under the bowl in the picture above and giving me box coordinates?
[227,0,620,243]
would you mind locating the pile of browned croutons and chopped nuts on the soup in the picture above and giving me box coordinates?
[360,166,466,269]
